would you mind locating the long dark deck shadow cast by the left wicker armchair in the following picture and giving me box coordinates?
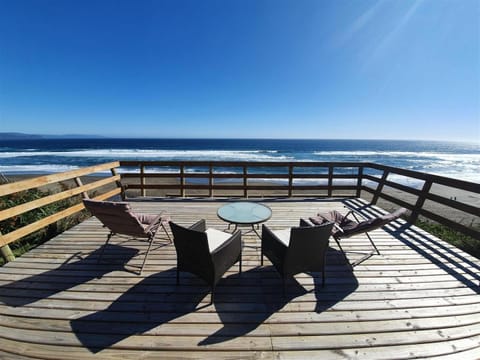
[70,268,209,353]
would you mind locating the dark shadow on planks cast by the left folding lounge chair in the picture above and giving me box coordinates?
[0,244,138,307]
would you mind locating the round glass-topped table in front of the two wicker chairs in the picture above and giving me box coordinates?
[217,201,272,237]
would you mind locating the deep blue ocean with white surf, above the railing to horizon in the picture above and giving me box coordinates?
[0,138,480,183]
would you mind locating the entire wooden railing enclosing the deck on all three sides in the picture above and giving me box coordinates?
[0,161,480,259]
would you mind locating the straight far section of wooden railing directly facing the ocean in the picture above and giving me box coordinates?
[119,161,363,197]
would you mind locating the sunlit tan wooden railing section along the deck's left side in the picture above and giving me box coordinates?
[0,162,122,261]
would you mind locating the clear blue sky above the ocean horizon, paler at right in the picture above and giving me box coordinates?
[0,0,480,143]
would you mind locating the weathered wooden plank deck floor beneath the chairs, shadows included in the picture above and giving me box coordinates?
[0,199,480,360]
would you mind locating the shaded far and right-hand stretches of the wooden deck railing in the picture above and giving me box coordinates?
[119,161,480,239]
